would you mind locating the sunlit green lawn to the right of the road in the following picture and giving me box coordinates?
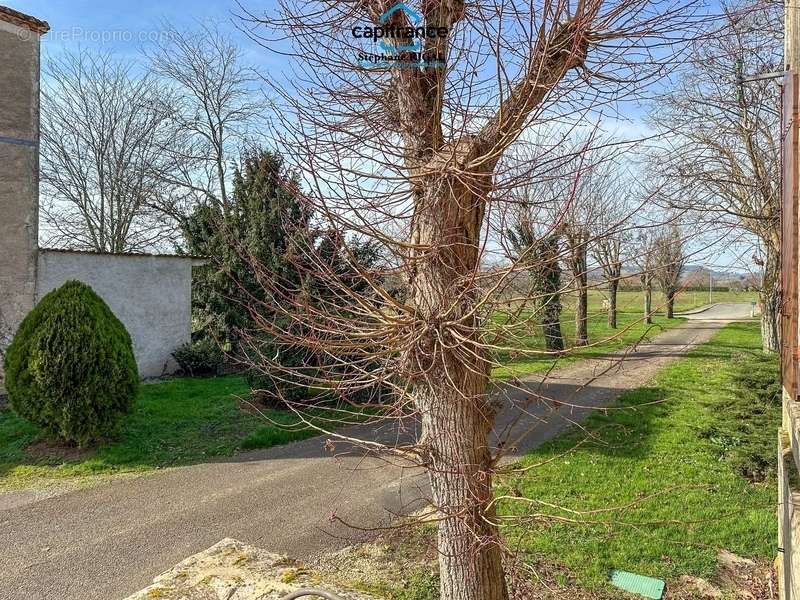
[498,323,780,588]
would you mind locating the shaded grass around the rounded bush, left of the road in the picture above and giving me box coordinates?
[0,376,360,489]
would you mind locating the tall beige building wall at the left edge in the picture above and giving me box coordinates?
[0,18,39,382]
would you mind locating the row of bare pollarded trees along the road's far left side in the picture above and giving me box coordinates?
[504,142,686,350]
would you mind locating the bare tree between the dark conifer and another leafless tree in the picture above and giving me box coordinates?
[146,24,265,218]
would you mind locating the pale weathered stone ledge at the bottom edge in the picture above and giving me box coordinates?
[125,538,379,600]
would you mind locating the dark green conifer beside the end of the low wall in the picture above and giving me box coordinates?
[184,150,312,351]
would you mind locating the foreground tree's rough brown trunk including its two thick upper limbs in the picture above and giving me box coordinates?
[396,8,590,600]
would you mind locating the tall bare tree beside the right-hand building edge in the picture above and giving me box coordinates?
[652,3,783,351]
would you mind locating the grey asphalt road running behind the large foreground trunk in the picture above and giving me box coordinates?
[0,304,750,600]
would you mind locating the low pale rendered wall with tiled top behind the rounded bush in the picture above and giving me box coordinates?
[36,249,197,377]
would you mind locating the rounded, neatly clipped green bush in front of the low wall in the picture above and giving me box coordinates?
[4,281,139,446]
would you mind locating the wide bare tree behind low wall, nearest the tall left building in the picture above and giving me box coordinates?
[41,52,173,252]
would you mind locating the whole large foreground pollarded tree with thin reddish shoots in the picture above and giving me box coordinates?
[232,0,700,600]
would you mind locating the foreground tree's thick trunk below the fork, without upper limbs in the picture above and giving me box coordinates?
[404,154,508,600]
